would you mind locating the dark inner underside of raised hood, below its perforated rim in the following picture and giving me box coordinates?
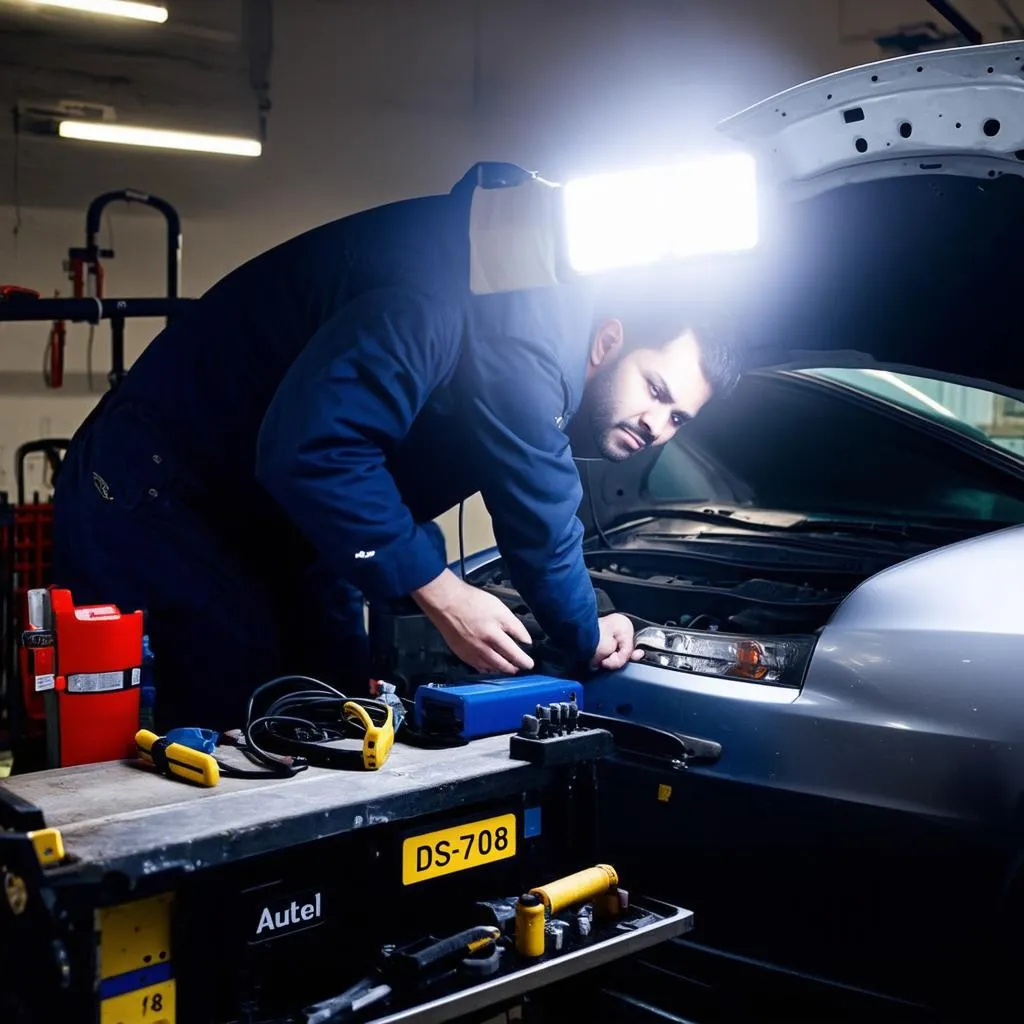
[728,175,1024,399]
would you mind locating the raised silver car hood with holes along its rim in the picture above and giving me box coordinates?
[681,42,1024,400]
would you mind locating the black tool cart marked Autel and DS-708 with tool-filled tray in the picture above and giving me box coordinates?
[0,715,704,1024]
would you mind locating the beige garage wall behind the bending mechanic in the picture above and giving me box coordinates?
[0,0,1007,553]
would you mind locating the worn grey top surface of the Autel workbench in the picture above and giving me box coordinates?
[0,736,546,878]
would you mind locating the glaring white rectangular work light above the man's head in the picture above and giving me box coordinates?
[564,153,758,273]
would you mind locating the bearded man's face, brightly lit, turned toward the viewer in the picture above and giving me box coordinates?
[573,321,712,462]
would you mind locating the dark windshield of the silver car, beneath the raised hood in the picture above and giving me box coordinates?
[645,370,1024,522]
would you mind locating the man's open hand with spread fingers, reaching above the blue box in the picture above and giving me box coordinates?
[412,569,536,675]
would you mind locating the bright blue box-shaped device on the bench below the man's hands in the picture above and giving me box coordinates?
[416,676,583,740]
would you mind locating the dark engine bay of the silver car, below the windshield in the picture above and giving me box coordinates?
[370,534,919,694]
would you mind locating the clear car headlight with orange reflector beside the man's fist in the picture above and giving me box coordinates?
[635,628,814,688]
